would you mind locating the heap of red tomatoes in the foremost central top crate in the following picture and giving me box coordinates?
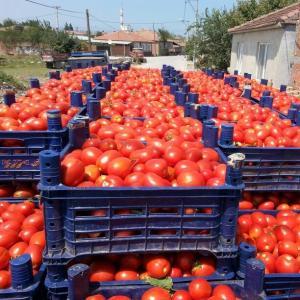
[61,138,226,187]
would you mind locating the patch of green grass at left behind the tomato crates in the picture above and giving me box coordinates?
[0,55,48,87]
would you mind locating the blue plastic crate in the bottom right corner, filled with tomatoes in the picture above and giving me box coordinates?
[239,210,300,299]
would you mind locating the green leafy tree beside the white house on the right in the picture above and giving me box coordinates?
[186,0,297,69]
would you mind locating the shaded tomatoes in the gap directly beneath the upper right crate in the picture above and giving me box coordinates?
[239,192,300,210]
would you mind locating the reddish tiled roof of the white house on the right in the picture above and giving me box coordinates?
[228,2,300,33]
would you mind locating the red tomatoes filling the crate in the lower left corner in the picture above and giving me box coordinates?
[0,201,46,289]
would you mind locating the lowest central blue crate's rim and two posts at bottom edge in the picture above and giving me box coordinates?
[46,259,265,300]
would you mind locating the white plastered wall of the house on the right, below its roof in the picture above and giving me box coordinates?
[230,26,296,87]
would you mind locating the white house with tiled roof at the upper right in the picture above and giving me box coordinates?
[229,3,300,87]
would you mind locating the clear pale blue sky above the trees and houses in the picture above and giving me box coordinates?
[0,0,236,34]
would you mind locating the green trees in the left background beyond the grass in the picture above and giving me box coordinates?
[0,19,80,53]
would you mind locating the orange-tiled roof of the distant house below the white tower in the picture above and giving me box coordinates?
[95,30,153,43]
